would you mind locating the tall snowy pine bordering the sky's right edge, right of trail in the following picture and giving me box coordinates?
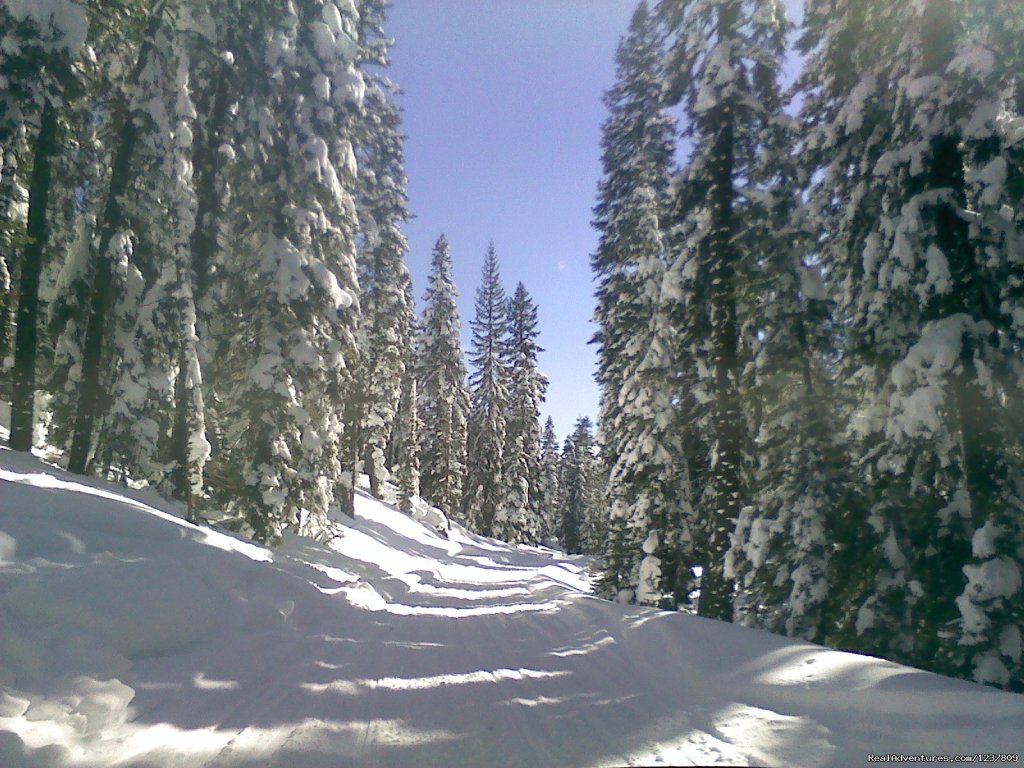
[592,2,690,602]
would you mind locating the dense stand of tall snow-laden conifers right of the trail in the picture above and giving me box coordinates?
[593,0,1024,690]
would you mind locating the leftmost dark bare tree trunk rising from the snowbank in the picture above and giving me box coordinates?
[10,101,57,451]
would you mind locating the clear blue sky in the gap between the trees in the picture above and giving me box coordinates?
[388,0,635,437]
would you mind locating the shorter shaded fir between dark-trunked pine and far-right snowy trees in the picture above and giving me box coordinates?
[727,111,855,642]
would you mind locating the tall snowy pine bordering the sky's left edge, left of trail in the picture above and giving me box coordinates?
[347,0,415,496]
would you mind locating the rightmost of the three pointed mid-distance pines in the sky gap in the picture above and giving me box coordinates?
[496,283,548,543]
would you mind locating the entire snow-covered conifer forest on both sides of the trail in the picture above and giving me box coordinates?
[0,0,1024,757]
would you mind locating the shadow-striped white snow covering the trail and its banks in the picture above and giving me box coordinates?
[0,451,1024,768]
